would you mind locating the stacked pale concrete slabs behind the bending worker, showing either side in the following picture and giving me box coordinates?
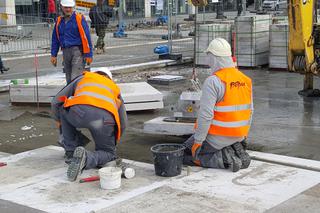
[10,77,163,111]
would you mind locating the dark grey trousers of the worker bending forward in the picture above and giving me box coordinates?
[61,105,116,169]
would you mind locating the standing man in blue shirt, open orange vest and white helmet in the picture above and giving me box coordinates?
[51,0,92,83]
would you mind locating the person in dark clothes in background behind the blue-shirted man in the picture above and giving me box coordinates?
[89,0,112,54]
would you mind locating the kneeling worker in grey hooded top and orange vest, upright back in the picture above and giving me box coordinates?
[184,38,253,172]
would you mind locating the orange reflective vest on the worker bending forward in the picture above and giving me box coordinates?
[64,72,122,141]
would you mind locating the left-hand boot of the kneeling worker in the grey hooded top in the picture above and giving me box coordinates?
[222,146,242,172]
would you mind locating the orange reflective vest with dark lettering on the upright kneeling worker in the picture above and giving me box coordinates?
[196,68,253,137]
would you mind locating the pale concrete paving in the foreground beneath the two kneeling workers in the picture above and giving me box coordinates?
[0,146,320,213]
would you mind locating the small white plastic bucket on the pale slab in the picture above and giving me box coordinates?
[99,167,122,189]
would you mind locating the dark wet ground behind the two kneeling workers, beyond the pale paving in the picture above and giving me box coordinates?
[0,66,320,162]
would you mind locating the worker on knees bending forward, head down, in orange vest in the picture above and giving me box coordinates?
[51,67,127,181]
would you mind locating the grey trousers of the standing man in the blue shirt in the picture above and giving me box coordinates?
[63,46,85,84]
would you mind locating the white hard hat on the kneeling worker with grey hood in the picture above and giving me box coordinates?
[206,38,232,56]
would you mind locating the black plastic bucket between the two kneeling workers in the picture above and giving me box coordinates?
[151,144,185,177]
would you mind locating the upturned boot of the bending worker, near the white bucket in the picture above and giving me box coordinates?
[67,146,87,181]
